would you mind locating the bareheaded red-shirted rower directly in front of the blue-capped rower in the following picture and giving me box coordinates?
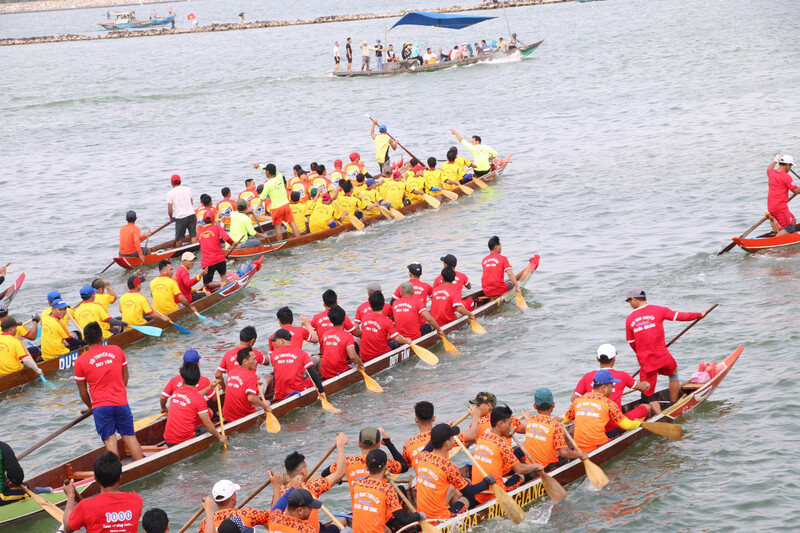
[164,362,228,446]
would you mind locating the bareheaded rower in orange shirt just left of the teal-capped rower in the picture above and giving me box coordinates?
[472,405,544,503]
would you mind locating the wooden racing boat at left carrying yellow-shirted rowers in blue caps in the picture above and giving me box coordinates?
[0,259,262,392]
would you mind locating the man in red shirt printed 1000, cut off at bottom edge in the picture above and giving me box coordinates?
[64,452,143,533]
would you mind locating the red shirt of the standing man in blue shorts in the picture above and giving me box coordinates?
[75,345,128,409]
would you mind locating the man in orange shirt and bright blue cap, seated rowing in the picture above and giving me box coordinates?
[564,369,642,453]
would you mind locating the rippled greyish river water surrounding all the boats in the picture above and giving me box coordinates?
[0,0,800,532]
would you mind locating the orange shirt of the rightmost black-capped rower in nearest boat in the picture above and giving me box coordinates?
[414,452,469,520]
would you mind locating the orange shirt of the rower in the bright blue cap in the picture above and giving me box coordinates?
[564,391,625,453]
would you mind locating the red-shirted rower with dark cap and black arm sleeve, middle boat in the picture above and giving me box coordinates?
[269,329,325,401]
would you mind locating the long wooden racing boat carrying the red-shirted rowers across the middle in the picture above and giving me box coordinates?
[0,268,531,525]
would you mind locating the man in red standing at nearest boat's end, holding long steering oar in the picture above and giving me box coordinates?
[625,287,708,403]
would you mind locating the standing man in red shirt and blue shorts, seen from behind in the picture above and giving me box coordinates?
[75,322,144,462]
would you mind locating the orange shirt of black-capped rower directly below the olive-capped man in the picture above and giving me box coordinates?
[350,479,403,533]
